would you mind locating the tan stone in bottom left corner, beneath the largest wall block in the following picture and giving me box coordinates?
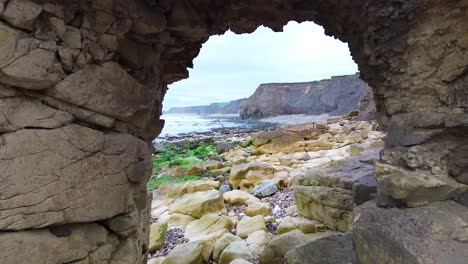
[0,223,118,264]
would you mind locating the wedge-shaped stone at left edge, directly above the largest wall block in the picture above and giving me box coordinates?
[0,97,73,132]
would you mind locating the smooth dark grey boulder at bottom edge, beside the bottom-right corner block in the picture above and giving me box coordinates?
[285,233,354,264]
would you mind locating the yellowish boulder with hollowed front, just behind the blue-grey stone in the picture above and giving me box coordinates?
[229,162,276,189]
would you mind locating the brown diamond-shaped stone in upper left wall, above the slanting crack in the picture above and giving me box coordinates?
[47,62,152,125]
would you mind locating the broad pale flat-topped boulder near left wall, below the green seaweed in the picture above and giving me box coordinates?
[169,190,226,218]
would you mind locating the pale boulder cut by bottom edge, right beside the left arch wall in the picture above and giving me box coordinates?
[161,240,213,264]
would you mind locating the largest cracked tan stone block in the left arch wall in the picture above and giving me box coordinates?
[0,124,151,230]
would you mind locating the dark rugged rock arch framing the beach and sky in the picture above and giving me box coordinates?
[0,0,468,263]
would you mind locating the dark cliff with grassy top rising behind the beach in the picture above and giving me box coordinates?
[240,74,367,118]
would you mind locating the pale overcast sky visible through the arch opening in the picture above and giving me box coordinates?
[164,22,358,110]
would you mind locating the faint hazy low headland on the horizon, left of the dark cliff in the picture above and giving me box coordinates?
[167,99,247,115]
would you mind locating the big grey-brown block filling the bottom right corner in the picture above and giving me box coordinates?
[353,201,468,264]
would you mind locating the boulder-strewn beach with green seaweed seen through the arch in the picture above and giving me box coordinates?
[148,114,385,264]
